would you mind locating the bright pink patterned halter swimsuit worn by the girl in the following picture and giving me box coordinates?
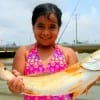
[24,46,72,100]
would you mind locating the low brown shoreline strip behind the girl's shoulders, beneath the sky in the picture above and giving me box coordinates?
[0,44,100,58]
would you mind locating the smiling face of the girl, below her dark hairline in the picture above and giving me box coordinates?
[33,14,59,46]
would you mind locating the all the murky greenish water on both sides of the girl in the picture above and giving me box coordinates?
[0,53,100,100]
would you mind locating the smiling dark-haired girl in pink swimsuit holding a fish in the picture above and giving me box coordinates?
[8,3,78,100]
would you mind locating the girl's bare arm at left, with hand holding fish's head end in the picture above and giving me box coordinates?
[7,47,25,93]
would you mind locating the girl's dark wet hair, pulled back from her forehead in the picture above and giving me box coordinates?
[32,3,62,27]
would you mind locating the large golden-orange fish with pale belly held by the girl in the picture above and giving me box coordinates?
[0,50,100,100]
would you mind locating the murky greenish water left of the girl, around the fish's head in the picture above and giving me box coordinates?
[0,58,23,100]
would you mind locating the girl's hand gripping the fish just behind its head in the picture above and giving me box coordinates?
[7,70,24,93]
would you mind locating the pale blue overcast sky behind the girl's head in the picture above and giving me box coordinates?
[0,0,100,45]
